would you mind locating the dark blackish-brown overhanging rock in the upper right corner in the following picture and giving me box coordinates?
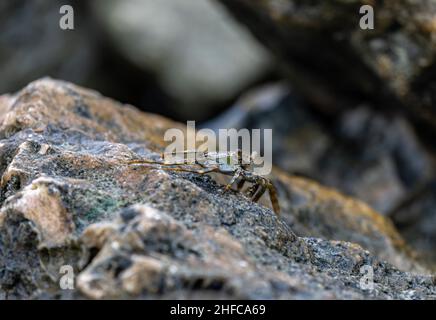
[220,0,436,138]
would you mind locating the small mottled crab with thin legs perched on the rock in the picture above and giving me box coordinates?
[127,149,280,215]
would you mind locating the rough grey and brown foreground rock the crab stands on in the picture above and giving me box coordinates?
[0,79,436,299]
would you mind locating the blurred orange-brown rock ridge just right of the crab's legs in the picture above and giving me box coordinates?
[276,171,424,272]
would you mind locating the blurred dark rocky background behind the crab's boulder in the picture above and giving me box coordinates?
[0,0,436,298]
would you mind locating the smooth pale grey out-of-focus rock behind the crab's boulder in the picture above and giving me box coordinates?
[92,0,271,120]
